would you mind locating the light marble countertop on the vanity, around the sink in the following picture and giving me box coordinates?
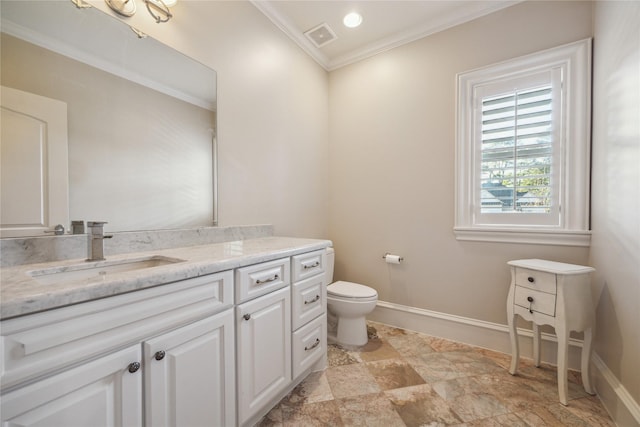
[0,237,331,319]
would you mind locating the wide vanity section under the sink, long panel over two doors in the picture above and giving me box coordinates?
[0,271,235,427]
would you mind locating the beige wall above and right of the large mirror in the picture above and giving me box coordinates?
[91,0,329,238]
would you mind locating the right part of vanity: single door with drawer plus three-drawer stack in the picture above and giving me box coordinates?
[236,249,327,426]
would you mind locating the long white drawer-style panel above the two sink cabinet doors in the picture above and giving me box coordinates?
[0,271,233,390]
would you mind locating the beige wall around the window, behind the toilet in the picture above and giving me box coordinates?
[329,2,591,324]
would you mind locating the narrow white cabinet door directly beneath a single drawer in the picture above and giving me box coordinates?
[236,287,291,424]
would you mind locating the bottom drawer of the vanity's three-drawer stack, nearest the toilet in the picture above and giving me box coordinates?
[291,315,327,379]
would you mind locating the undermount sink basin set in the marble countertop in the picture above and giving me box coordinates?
[28,256,184,284]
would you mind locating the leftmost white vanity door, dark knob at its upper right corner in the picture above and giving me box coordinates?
[2,345,142,427]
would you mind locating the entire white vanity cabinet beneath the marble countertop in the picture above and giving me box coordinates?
[0,244,326,427]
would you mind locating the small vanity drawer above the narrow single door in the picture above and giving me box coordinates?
[236,258,291,304]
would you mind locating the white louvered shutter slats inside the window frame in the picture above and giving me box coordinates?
[479,84,553,213]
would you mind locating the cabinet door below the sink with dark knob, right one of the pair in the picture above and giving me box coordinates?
[143,309,235,427]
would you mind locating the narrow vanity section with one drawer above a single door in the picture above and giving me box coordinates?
[236,258,291,425]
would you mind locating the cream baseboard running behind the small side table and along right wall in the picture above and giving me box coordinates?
[367,301,640,427]
